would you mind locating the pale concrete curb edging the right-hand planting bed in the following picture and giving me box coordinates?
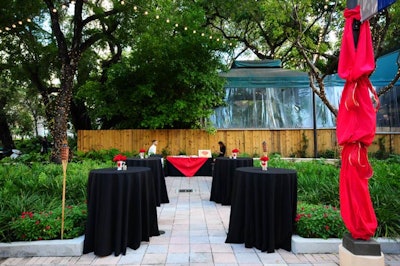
[292,235,400,254]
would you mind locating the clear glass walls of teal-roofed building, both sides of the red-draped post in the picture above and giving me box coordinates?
[211,86,400,132]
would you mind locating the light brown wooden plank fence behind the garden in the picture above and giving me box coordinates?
[78,129,400,157]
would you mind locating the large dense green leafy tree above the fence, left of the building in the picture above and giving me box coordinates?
[76,1,230,129]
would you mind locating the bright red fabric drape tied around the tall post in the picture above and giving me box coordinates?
[336,6,379,240]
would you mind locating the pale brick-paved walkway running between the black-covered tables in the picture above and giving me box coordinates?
[0,177,400,266]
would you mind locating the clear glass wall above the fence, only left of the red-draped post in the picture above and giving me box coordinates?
[211,88,340,129]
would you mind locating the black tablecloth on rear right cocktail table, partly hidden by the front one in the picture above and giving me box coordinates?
[210,157,253,205]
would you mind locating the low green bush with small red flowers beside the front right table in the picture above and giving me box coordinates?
[296,202,347,239]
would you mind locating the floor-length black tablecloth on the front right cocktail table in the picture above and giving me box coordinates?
[226,167,297,253]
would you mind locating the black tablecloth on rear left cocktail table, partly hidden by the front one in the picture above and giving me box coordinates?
[126,157,169,206]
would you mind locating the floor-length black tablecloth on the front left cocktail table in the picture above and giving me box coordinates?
[83,167,160,256]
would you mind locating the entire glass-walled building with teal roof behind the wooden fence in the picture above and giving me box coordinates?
[211,53,400,131]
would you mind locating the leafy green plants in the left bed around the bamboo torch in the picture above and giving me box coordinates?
[0,157,109,242]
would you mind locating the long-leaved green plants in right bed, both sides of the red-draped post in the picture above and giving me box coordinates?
[268,155,400,237]
